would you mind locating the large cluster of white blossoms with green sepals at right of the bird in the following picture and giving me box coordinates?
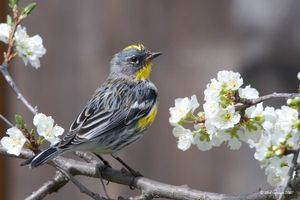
[169,71,300,186]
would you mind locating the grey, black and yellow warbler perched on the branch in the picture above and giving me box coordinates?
[30,44,161,170]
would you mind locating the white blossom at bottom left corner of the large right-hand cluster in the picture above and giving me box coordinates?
[173,126,194,151]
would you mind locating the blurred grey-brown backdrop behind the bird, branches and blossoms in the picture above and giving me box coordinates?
[0,0,300,200]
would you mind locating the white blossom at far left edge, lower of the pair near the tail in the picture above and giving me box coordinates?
[1,127,27,156]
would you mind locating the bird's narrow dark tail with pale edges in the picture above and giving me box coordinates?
[28,147,62,168]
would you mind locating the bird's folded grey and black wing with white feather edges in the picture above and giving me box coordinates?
[59,79,157,147]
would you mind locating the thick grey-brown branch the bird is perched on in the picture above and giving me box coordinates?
[0,144,286,200]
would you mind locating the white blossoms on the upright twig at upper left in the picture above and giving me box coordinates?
[0,23,46,69]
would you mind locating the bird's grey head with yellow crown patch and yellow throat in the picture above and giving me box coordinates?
[110,44,161,80]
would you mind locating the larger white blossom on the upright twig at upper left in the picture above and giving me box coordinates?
[15,25,46,69]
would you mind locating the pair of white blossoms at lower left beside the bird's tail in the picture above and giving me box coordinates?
[1,113,64,156]
